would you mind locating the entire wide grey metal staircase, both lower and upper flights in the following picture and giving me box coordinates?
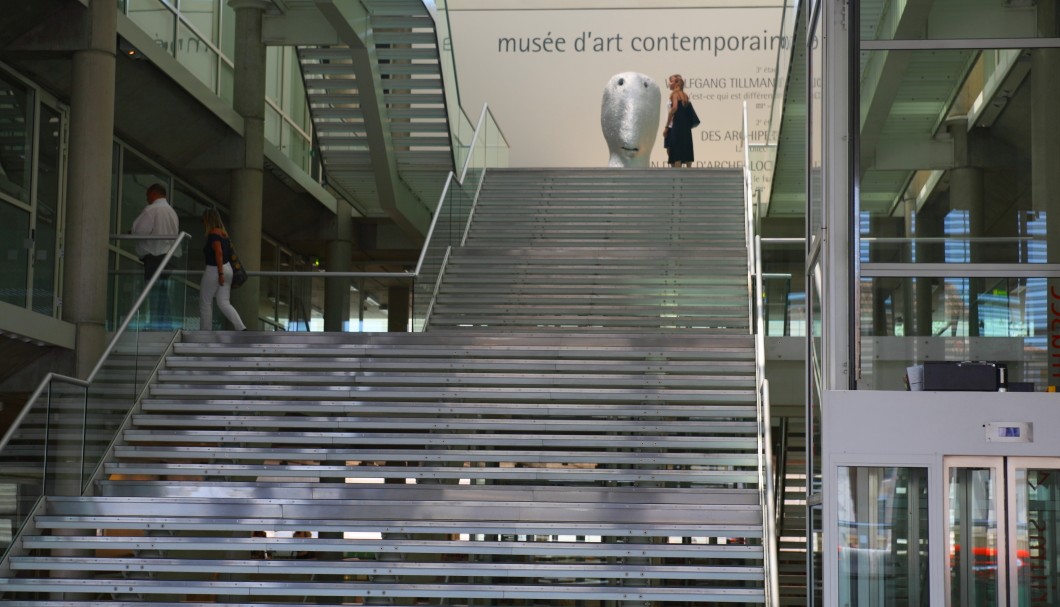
[0,169,769,606]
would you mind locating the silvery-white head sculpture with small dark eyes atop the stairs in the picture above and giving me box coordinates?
[600,72,663,167]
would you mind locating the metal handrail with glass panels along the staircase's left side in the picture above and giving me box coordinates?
[0,105,508,563]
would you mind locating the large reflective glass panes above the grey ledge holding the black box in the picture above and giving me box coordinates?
[859,38,1060,390]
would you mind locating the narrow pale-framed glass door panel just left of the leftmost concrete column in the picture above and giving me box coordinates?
[32,106,63,316]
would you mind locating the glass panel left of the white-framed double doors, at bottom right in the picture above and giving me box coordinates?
[836,466,931,607]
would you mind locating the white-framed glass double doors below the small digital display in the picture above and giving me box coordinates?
[946,458,1060,607]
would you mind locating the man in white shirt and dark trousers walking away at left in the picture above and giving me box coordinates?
[133,183,180,328]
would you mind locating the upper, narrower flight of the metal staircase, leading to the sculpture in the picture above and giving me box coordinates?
[430,169,750,339]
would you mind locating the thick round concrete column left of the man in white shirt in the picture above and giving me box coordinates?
[63,0,118,377]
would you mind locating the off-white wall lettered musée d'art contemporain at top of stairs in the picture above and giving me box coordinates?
[448,0,790,167]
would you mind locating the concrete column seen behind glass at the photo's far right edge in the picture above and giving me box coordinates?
[1030,2,1060,386]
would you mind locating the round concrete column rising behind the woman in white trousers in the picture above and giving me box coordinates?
[228,0,269,329]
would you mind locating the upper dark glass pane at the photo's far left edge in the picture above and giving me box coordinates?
[0,73,34,203]
